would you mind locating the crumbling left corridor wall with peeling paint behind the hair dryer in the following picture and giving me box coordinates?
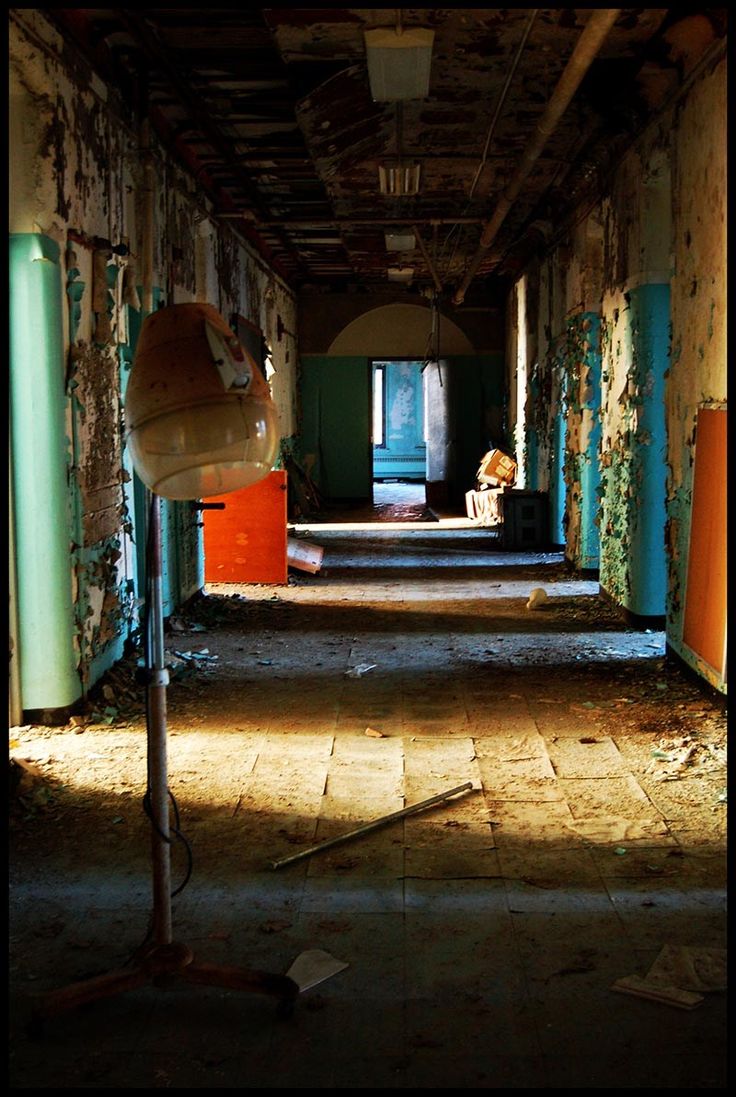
[9,9,296,706]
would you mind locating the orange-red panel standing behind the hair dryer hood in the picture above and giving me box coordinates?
[202,470,287,584]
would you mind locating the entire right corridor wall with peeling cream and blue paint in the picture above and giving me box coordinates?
[507,49,726,690]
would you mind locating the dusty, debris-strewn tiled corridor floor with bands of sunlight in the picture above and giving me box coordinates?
[10,489,726,1089]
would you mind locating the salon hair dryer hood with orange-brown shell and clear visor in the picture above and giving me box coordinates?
[125,304,279,499]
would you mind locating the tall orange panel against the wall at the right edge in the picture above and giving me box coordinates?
[682,408,727,677]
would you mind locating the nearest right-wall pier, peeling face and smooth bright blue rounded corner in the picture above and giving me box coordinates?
[600,132,671,618]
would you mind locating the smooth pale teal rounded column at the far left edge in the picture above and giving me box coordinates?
[10,234,81,710]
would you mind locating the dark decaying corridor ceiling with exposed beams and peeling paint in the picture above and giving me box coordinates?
[44,7,726,299]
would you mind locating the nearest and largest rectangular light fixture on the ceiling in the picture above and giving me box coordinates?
[363,26,434,103]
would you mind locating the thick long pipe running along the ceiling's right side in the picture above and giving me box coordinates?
[453,8,621,305]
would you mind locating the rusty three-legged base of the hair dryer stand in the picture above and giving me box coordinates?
[31,941,299,1030]
